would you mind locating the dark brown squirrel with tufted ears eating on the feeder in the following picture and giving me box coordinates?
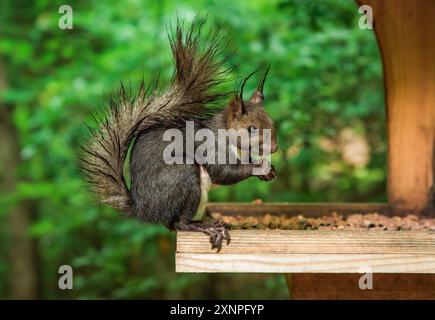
[81,19,277,250]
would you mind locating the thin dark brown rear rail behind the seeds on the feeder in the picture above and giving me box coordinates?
[207,202,389,217]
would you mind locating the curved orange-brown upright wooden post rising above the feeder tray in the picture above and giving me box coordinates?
[358,0,435,215]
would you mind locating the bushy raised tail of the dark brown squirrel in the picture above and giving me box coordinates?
[80,19,233,214]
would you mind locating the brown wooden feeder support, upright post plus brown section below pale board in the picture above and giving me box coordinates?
[286,0,435,299]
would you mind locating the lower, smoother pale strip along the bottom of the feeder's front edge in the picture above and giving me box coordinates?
[176,253,435,273]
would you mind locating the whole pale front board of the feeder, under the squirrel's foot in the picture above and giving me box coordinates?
[176,230,435,273]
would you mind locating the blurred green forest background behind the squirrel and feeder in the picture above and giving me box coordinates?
[0,0,386,299]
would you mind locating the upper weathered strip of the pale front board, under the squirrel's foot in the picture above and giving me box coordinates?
[177,230,435,256]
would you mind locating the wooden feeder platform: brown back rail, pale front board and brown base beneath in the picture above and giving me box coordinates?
[175,203,435,299]
